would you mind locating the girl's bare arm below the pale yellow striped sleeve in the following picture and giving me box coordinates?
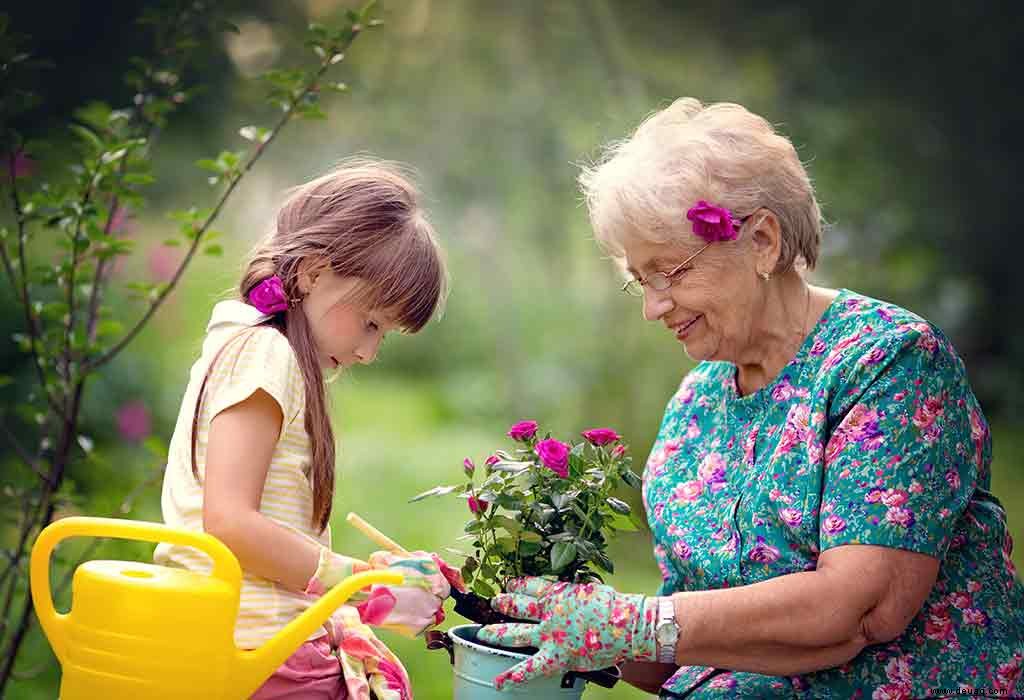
[203,389,321,590]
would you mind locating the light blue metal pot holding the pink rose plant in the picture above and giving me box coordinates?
[447,624,587,700]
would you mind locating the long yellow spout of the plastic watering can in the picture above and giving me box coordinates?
[231,571,402,697]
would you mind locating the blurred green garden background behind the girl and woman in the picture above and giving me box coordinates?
[0,0,1024,699]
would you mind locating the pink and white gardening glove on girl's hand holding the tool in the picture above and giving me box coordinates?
[355,552,452,638]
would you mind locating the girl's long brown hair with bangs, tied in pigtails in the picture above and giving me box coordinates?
[191,158,447,531]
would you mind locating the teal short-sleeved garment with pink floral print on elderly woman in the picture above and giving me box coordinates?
[643,290,1024,700]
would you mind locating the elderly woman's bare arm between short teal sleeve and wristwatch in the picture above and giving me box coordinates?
[673,544,939,675]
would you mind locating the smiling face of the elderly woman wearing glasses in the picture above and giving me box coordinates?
[624,236,759,361]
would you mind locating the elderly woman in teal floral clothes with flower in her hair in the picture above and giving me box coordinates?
[481,99,1024,699]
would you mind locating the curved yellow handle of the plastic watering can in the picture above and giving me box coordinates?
[30,517,242,663]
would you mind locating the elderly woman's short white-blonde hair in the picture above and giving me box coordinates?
[580,97,821,272]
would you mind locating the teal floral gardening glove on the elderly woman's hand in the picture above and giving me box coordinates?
[477,576,657,690]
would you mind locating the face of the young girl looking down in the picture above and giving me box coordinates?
[302,269,398,369]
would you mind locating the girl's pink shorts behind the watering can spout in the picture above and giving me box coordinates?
[252,635,348,700]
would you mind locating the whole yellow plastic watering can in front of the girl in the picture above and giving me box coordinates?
[31,518,402,700]
